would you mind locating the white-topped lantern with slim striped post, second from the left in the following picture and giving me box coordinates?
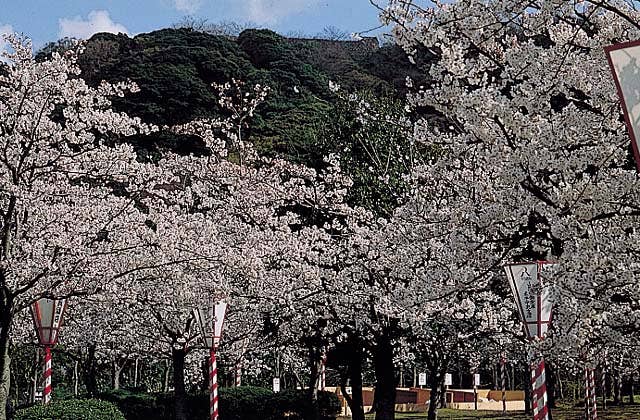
[194,301,227,420]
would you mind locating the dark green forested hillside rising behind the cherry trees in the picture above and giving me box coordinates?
[39,28,438,216]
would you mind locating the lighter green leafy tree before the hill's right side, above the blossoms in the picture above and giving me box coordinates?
[320,91,418,217]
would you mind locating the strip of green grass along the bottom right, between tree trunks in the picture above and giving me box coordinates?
[356,404,640,420]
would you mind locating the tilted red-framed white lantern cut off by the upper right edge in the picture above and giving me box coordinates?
[605,41,640,170]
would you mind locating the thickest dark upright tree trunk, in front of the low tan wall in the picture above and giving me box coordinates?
[373,333,396,420]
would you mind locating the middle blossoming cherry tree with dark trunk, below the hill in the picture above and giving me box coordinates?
[93,81,362,418]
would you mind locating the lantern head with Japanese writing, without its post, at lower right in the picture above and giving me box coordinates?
[504,261,553,338]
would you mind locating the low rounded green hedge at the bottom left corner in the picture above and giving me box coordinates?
[14,400,125,420]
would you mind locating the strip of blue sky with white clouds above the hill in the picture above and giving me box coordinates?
[0,0,383,48]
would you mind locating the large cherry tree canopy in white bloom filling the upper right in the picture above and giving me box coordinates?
[382,0,640,410]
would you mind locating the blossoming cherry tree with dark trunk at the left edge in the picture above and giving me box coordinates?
[0,36,160,418]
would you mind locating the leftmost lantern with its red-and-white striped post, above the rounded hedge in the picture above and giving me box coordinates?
[31,298,67,404]
